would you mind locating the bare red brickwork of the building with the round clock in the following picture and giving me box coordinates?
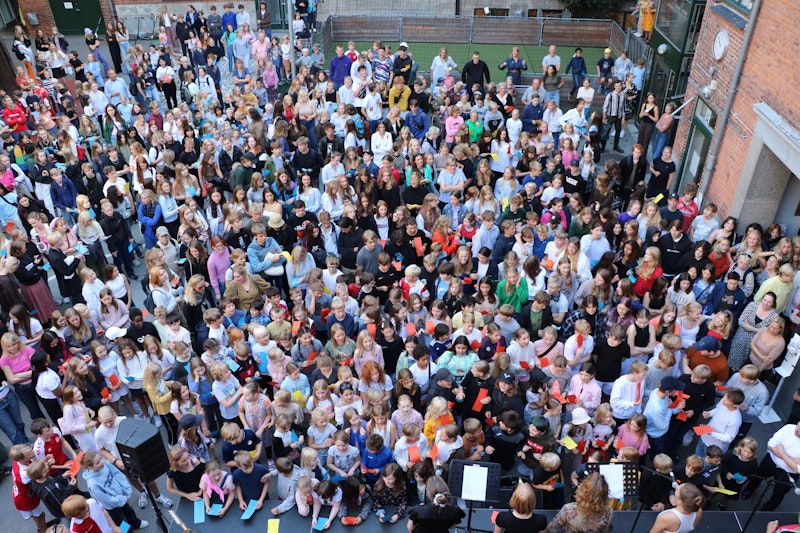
[675,0,800,216]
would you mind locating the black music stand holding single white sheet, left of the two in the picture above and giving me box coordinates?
[448,461,501,533]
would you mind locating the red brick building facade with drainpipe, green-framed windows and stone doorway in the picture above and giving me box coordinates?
[674,0,800,235]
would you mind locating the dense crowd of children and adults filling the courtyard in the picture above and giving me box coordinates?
[0,7,800,532]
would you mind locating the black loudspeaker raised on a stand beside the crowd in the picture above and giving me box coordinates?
[117,418,169,483]
